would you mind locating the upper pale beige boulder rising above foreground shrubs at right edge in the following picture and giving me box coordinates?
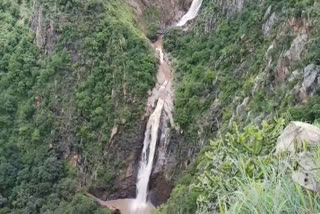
[276,122,320,153]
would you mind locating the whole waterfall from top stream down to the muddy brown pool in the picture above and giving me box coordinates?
[89,0,202,214]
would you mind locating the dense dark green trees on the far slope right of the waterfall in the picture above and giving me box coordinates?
[165,0,320,142]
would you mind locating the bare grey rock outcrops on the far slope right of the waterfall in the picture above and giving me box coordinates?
[201,0,318,135]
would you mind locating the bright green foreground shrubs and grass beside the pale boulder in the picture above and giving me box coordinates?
[159,119,320,214]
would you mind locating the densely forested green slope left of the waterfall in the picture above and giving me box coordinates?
[0,0,155,213]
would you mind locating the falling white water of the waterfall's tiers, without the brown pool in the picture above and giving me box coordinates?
[132,0,203,209]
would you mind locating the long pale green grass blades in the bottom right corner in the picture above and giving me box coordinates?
[220,173,320,214]
